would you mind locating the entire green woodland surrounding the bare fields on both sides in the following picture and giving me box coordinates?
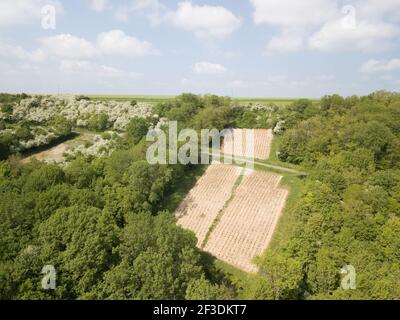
[0,92,400,299]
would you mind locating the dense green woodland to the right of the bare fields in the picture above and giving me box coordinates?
[254,92,400,299]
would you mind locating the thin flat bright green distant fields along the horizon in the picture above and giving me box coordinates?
[89,95,318,106]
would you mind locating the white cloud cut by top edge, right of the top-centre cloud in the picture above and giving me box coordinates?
[250,0,337,28]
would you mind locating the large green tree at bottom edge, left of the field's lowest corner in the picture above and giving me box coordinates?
[102,213,204,299]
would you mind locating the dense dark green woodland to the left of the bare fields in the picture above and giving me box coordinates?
[0,95,233,299]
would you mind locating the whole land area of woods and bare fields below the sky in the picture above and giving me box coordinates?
[0,92,400,300]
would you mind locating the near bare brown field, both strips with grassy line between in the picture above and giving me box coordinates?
[177,164,288,272]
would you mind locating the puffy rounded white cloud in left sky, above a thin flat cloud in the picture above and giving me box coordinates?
[97,30,158,57]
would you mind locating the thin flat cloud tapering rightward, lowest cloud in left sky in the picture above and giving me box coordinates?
[60,60,142,78]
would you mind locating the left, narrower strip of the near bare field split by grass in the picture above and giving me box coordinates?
[176,164,240,247]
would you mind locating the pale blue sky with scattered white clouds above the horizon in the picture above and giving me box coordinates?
[0,0,400,97]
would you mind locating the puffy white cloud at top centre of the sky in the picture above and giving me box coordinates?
[168,1,241,38]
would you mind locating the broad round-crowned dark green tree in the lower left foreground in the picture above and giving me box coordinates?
[39,206,119,298]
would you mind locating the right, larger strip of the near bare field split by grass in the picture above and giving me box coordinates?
[204,172,288,272]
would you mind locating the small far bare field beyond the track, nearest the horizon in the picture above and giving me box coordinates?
[222,129,273,160]
